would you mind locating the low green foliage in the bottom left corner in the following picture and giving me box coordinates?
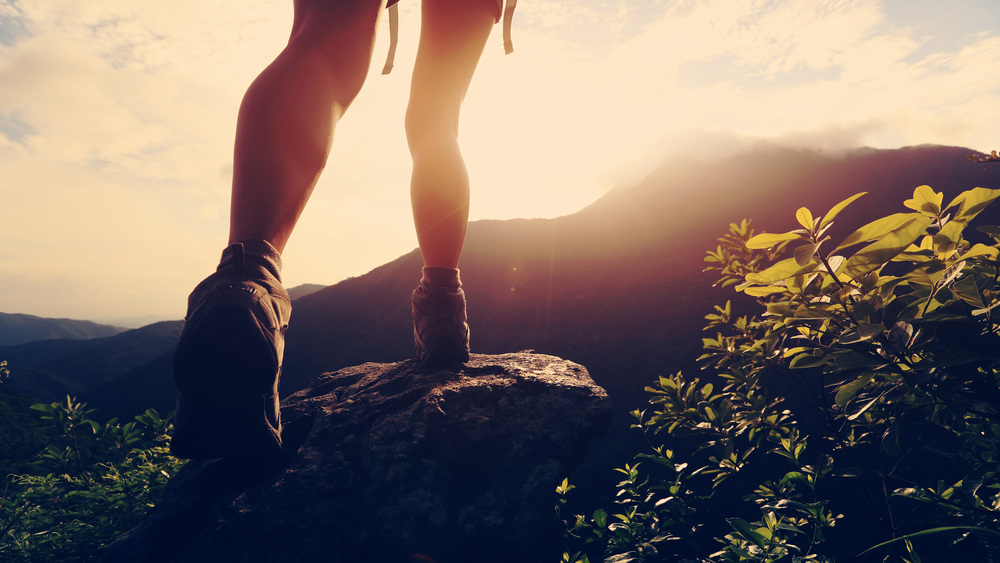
[0,396,184,562]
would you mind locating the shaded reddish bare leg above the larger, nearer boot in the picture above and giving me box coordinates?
[229,0,386,252]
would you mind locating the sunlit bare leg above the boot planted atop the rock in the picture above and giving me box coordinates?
[406,0,497,268]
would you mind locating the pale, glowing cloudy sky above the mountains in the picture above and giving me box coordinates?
[0,0,1000,321]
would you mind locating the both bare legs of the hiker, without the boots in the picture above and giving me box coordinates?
[229,0,497,262]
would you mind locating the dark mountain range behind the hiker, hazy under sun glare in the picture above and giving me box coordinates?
[0,146,1000,502]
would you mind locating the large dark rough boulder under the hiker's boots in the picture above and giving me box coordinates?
[99,352,611,563]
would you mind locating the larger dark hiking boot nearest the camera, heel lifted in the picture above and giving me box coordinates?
[170,240,292,458]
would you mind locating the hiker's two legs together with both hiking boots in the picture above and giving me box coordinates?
[172,0,508,458]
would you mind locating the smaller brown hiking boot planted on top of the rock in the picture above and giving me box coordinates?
[411,268,469,366]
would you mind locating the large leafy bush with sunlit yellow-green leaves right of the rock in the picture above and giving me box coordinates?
[557,186,1000,563]
